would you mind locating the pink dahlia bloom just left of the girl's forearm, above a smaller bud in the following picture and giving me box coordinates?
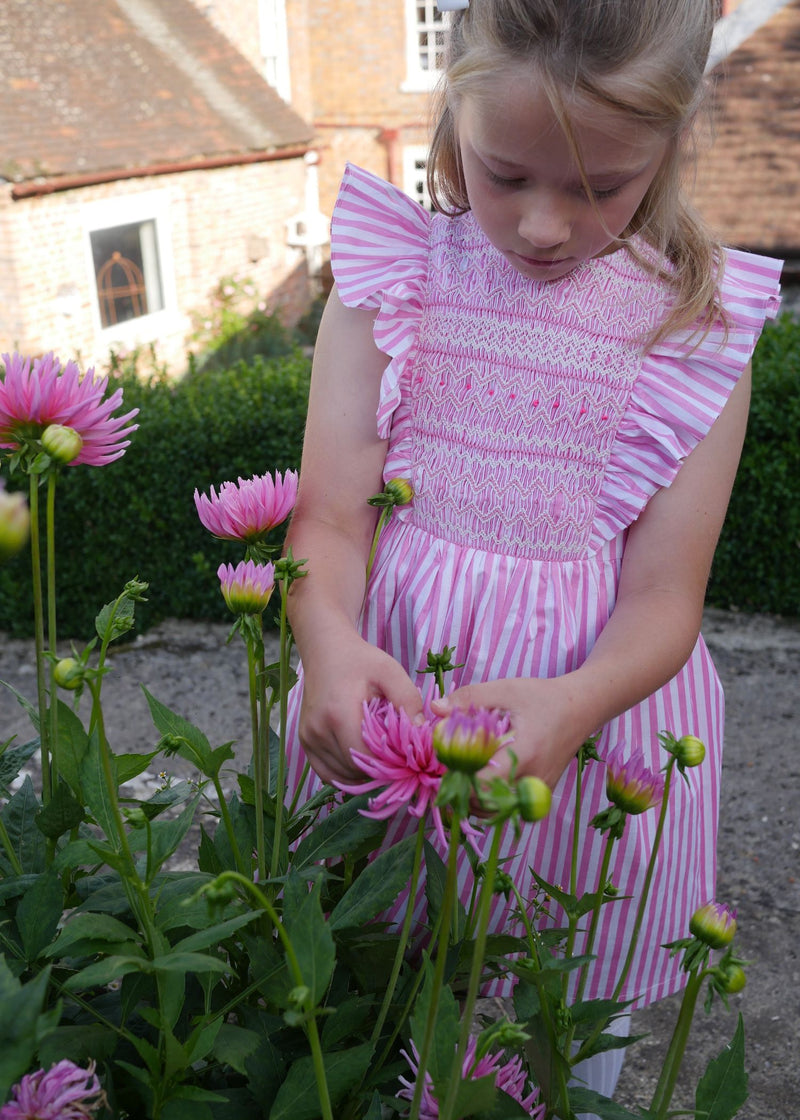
[195,470,297,544]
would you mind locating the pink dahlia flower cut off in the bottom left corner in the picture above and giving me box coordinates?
[0,1058,105,1120]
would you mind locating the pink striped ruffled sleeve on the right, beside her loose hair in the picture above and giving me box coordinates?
[593,250,782,548]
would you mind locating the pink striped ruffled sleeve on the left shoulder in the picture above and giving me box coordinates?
[331,164,430,439]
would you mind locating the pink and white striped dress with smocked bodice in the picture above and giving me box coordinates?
[284,167,780,1006]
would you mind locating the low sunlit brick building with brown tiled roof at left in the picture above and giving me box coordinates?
[0,0,315,371]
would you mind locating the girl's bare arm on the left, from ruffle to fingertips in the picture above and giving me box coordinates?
[287,289,421,782]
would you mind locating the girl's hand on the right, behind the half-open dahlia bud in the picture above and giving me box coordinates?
[431,676,594,788]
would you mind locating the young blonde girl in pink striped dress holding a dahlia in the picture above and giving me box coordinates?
[282,0,780,1092]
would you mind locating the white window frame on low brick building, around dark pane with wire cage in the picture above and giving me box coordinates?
[82,190,178,347]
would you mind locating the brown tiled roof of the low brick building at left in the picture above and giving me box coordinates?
[0,0,311,183]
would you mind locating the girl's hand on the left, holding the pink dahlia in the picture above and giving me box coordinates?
[299,631,422,783]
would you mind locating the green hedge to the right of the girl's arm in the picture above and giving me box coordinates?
[708,315,800,616]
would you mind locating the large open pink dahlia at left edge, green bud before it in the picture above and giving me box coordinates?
[0,354,139,467]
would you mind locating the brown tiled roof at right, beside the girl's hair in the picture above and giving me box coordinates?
[695,0,800,258]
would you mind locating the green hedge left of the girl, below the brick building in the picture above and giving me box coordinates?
[0,351,310,638]
